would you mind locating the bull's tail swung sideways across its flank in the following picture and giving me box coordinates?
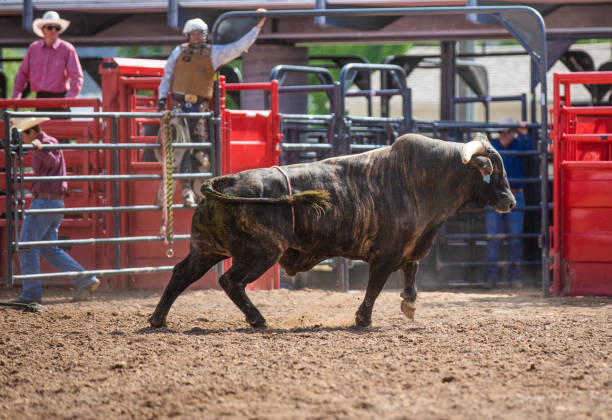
[201,181,331,213]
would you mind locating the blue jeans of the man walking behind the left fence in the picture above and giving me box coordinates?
[19,198,96,301]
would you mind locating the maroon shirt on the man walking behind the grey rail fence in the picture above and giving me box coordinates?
[32,131,68,194]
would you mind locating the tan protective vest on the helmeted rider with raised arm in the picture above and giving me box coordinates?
[172,44,215,99]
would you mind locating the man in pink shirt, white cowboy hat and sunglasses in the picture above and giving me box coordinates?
[13,11,83,99]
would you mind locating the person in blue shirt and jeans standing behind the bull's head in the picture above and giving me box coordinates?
[484,117,533,288]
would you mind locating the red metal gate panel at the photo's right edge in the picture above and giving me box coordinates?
[551,72,612,295]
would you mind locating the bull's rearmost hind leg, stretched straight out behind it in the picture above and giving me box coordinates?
[149,253,227,328]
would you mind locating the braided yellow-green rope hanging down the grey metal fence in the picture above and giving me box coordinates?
[160,113,177,258]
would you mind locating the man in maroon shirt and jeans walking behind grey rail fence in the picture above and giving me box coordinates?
[11,117,100,303]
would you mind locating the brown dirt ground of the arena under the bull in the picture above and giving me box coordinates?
[0,289,612,419]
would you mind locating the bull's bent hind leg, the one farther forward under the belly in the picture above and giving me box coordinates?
[219,255,277,329]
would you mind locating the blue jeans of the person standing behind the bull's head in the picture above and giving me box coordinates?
[485,192,525,283]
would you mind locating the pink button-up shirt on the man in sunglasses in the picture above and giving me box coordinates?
[13,38,83,98]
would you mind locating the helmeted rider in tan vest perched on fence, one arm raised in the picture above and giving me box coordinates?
[156,8,266,205]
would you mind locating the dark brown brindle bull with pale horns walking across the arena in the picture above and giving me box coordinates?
[150,134,515,328]
